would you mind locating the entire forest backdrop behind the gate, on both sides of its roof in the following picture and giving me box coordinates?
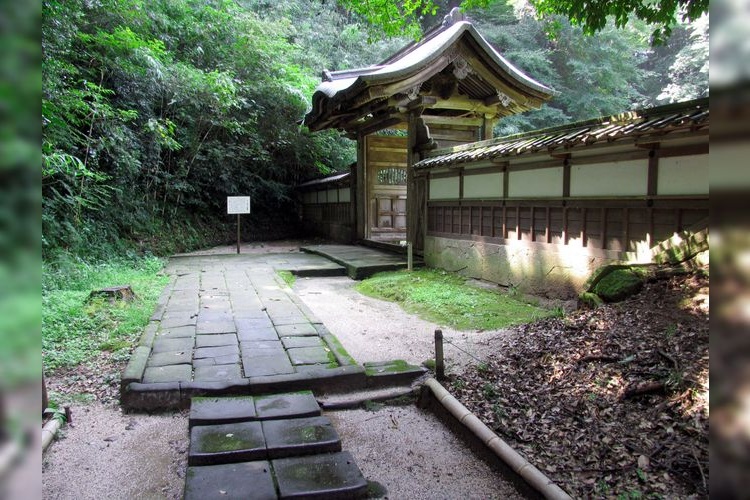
[42,0,708,260]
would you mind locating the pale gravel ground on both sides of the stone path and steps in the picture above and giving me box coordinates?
[42,250,518,500]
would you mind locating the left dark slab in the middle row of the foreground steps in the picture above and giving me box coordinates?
[188,422,266,465]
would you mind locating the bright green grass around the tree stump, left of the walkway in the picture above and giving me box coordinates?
[42,257,169,370]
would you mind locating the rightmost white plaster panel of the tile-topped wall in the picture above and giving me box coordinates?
[656,155,708,195]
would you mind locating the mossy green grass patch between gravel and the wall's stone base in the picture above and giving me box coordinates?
[356,269,553,330]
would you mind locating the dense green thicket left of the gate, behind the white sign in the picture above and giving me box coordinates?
[42,0,354,258]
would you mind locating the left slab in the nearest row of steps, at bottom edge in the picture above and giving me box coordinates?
[183,460,277,500]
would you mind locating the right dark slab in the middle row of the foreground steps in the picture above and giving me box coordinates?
[263,417,341,458]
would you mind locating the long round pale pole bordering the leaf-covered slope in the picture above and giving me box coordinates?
[420,378,571,500]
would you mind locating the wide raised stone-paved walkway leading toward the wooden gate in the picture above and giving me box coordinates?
[122,248,426,409]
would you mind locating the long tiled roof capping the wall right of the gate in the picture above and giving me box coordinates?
[414,99,709,169]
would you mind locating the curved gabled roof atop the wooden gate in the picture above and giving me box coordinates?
[305,9,553,132]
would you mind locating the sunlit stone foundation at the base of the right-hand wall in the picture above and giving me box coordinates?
[424,236,617,299]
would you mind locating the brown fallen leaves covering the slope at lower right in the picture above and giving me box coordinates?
[449,273,709,498]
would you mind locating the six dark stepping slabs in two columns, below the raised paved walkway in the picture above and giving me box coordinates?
[184,391,367,500]
